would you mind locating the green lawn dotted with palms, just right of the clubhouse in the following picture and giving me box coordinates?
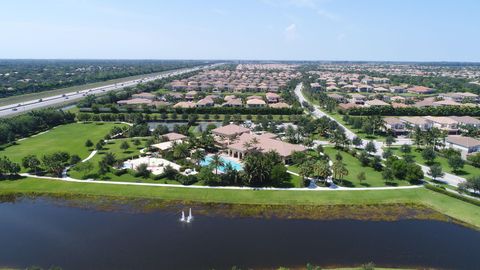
[324,147,409,187]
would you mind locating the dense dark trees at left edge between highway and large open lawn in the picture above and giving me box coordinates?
[0,109,75,145]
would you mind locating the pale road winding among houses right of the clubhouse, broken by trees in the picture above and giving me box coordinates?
[295,83,466,187]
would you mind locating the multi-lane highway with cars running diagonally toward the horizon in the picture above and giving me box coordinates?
[0,63,222,117]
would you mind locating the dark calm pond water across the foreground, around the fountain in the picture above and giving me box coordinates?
[0,199,480,269]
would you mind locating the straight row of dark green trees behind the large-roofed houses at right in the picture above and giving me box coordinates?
[340,106,480,116]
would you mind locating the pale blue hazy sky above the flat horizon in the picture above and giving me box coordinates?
[0,0,480,62]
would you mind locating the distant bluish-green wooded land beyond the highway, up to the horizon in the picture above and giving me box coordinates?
[0,60,205,98]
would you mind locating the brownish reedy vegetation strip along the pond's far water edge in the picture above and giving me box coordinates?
[0,194,472,230]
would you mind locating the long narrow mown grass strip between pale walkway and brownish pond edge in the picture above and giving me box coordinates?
[0,178,480,228]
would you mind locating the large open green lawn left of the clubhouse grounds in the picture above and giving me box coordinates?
[0,123,127,168]
